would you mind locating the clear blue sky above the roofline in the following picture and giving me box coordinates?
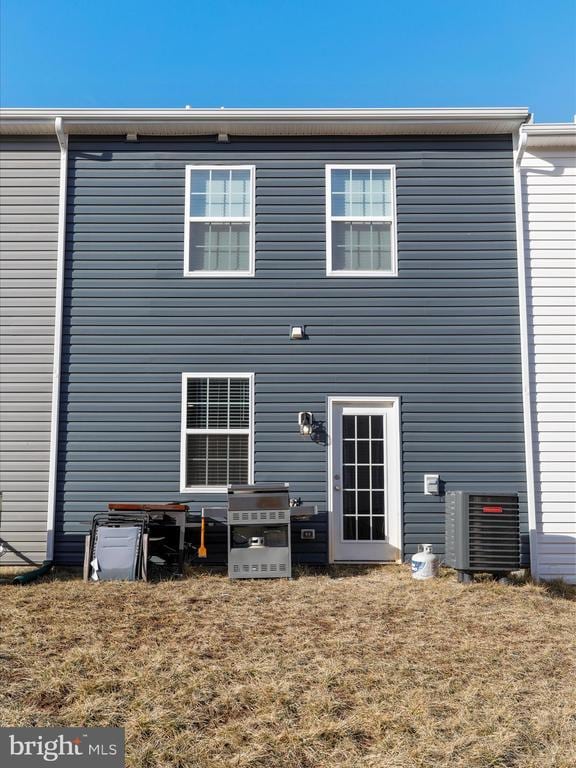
[0,0,576,122]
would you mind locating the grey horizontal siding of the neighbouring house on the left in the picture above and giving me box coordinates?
[0,138,60,565]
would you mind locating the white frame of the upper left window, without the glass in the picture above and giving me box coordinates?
[184,163,256,278]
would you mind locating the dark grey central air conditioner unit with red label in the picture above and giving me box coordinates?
[444,491,521,581]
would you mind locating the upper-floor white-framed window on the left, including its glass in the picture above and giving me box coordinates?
[184,165,255,277]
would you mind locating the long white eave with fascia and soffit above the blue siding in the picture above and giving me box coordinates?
[0,107,530,135]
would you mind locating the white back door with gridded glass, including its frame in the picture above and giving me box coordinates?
[328,398,401,562]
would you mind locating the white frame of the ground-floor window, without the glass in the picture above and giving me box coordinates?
[180,371,254,493]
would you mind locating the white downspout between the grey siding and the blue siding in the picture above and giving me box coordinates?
[46,117,68,561]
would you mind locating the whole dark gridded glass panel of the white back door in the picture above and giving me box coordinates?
[342,414,386,541]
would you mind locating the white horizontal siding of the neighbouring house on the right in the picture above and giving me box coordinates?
[521,148,576,583]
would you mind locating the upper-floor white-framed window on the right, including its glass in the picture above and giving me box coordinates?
[326,165,398,277]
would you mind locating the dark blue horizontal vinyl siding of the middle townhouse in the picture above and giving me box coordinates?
[56,136,526,562]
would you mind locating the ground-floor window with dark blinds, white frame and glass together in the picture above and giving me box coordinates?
[180,373,254,493]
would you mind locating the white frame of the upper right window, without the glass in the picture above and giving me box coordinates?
[326,163,398,277]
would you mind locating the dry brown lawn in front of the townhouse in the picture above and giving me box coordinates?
[0,566,576,768]
